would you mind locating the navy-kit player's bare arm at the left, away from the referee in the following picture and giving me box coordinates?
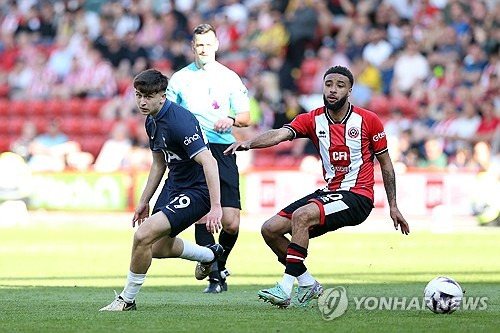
[132,153,167,227]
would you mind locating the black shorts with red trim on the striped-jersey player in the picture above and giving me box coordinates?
[278,190,373,238]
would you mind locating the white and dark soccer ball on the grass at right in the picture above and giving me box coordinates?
[424,276,463,313]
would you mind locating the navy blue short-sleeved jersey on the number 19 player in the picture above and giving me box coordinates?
[146,100,208,189]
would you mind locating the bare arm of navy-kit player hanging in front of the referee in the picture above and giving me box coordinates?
[194,150,222,233]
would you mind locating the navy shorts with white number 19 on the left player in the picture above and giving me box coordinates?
[153,186,210,237]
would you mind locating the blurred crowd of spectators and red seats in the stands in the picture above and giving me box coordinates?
[0,0,500,172]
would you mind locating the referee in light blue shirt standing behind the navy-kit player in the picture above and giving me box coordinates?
[167,23,250,293]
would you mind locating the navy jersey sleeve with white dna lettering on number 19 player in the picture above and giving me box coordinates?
[175,112,208,159]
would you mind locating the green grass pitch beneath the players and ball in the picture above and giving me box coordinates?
[0,214,500,332]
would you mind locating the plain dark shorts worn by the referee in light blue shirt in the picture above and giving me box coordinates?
[210,143,241,209]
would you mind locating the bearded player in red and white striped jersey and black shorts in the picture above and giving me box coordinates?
[224,66,410,307]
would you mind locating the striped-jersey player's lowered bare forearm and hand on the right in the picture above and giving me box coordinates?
[377,152,410,235]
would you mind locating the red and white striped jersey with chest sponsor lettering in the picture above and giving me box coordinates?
[283,105,387,201]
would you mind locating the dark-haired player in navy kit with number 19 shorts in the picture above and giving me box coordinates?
[100,69,223,311]
